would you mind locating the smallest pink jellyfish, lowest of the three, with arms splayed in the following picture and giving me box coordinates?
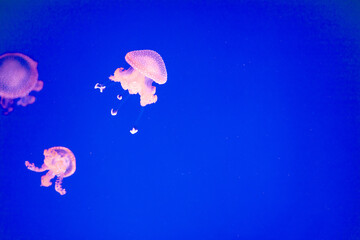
[25,147,76,195]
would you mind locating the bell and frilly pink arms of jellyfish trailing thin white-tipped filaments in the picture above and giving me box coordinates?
[109,50,167,107]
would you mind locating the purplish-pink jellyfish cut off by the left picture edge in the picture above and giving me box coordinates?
[0,53,44,113]
